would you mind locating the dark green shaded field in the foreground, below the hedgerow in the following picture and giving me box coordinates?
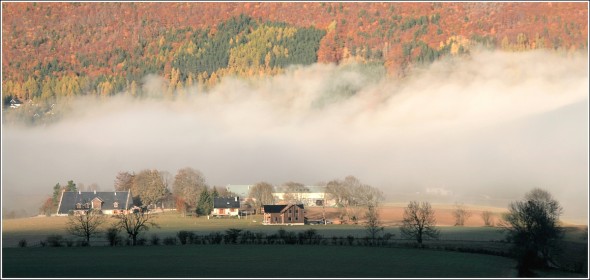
[2,245,515,278]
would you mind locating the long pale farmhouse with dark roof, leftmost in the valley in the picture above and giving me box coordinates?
[57,191,133,216]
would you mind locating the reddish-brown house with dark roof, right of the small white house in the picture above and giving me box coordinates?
[262,204,305,225]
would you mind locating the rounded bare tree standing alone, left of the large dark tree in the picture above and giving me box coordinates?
[400,201,440,244]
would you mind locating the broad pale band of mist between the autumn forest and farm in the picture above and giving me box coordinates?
[2,51,589,222]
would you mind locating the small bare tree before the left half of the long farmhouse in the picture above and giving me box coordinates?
[66,210,105,245]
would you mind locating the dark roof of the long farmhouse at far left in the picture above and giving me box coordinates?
[57,191,133,214]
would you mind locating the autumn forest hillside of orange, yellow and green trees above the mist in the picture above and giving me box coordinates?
[2,2,588,123]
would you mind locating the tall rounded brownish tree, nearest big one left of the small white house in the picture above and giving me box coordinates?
[172,167,207,213]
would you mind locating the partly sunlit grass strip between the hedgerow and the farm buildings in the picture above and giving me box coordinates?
[2,212,504,247]
